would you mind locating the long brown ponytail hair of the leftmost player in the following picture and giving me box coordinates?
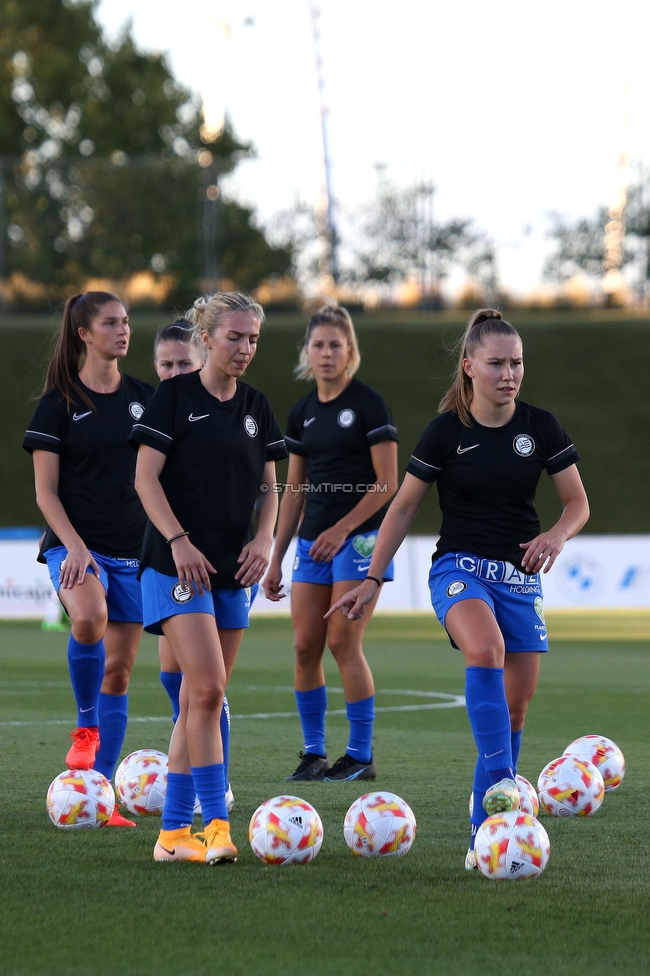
[43,291,121,410]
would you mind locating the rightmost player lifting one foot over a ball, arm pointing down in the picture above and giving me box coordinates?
[330,309,589,870]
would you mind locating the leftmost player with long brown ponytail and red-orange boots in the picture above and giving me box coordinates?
[23,291,153,826]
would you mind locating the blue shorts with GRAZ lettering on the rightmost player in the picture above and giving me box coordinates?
[429,552,548,651]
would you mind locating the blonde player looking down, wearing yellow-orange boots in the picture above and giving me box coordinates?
[132,292,286,864]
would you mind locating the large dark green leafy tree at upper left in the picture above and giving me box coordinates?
[0,0,291,297]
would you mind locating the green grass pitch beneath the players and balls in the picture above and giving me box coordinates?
[0,618,650,976]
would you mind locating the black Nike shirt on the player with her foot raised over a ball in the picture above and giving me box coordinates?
[406,401,579,567]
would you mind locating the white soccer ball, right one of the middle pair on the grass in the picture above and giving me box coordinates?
[343,791,418,857]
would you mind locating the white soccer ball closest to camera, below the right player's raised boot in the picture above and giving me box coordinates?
[474,810,551,881]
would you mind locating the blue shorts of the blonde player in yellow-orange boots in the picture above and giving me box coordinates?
[141,566,251,637]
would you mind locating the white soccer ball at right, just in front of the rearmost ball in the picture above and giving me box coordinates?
[537,756,605,817]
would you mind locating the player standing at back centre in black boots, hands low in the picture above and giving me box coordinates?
[263,305,397,781]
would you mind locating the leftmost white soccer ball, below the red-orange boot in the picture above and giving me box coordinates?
[46,769,115,830]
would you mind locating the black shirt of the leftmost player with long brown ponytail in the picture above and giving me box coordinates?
[23,373,153,559]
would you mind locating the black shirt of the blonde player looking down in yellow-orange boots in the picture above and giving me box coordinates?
[130,370,287,588]
